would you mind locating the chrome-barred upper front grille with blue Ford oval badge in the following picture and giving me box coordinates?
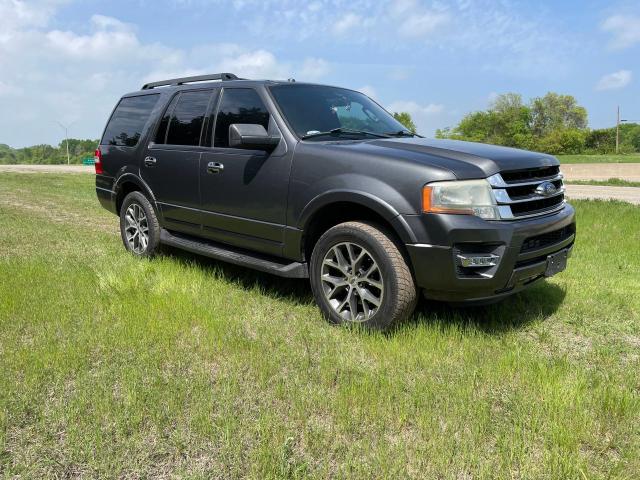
[488,166,565,220]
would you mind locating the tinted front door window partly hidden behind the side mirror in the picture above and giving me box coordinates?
[214,88,269,147]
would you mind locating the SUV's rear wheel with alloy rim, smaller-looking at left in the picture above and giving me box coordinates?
[120,192,160,257]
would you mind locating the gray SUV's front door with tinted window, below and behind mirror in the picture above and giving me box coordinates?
[200,88,291,255]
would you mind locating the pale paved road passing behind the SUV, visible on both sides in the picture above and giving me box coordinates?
[0,163,640,205]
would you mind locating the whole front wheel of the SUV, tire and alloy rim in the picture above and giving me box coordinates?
[310,222,417,330]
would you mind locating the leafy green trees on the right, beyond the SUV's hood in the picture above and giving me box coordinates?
[436,92,640,155]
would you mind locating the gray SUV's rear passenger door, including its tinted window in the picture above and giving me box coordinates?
[140,89,217,234]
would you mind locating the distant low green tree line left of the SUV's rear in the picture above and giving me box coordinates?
[0,138,99,165]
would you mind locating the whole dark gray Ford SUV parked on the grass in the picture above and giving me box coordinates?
[95,73,575,328]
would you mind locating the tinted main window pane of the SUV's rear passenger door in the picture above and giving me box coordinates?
[166,90,211,145]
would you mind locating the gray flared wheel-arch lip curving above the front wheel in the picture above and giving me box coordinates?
[298,190,417,243]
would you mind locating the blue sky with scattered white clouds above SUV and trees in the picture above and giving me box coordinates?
[0,0,640,147]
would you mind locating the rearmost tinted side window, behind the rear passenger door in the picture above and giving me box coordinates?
[100,94,159,147]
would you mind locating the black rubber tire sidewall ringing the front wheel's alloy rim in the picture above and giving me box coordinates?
[310,225,410,329]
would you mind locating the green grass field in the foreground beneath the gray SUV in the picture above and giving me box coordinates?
[0,174,640,479]
